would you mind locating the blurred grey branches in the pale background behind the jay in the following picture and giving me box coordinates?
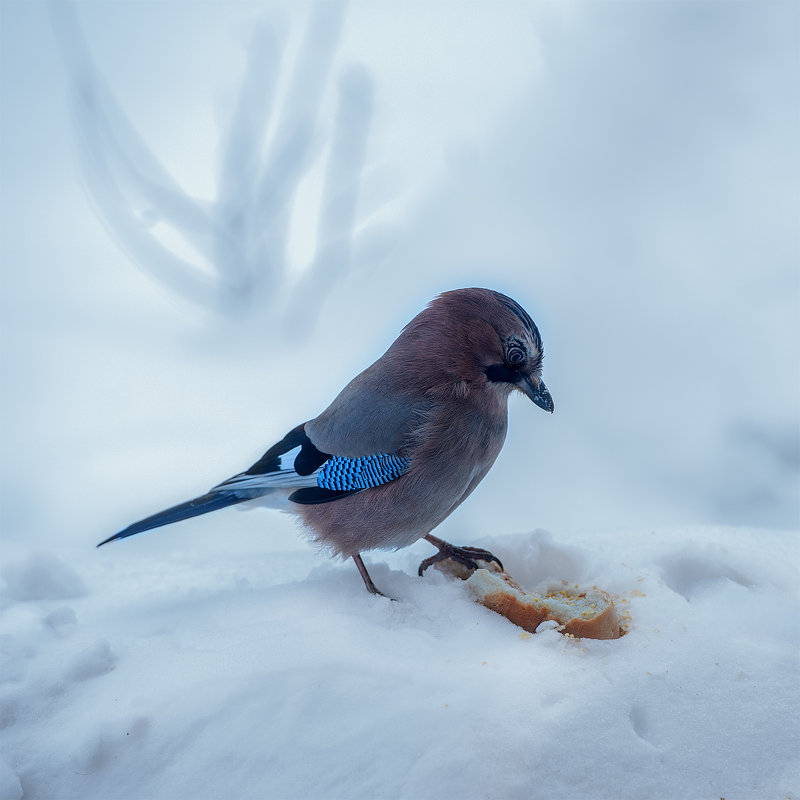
[51,0,382,319]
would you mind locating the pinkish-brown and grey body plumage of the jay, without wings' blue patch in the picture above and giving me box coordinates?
[300,289,552,556]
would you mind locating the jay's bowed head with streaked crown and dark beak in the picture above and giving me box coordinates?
[398,289,554,412]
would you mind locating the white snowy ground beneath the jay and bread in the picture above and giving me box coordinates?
[0,524,800,800]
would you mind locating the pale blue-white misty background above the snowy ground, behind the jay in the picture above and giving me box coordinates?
[0,1,800,557]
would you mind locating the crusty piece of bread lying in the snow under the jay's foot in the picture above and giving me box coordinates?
[436,560,624,639]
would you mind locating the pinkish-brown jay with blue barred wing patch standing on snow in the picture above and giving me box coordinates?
[97,288,554,595]
